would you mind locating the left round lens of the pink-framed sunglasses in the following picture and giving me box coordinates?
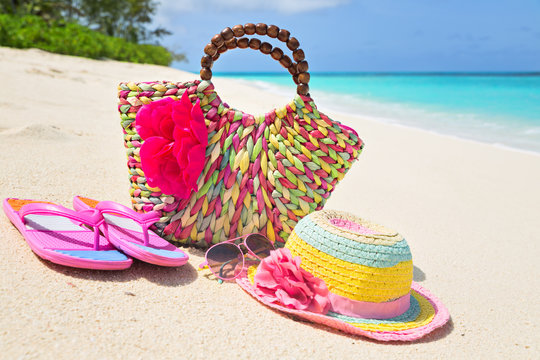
[206,243,244,280]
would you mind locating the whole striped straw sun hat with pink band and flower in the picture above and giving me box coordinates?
[237,211,449,341]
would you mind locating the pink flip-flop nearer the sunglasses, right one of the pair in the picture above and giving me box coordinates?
[73,196,189,266]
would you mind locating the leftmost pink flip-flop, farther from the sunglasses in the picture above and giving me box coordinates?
[3,198,133,270]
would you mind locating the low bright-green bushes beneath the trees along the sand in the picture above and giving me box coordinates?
[0,14,174,65]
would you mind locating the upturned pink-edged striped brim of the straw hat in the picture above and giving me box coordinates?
[236,275,450,341]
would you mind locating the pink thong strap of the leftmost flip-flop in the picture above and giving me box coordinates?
[19,203,105,250]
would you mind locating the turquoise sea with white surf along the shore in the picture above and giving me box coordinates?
[215,73,540,154]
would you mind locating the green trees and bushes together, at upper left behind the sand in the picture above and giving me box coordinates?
[0,0,186,65]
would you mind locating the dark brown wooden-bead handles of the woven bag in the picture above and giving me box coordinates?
[200,23,310,95]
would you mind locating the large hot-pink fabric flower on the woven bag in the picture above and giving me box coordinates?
[135,91,208,199]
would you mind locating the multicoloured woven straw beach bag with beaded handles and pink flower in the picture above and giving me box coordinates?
[118,24,363,247]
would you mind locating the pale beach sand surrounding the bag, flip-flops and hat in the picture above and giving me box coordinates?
[0,48,540,359]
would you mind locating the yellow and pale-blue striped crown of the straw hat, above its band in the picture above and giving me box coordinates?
[285,210,413,303]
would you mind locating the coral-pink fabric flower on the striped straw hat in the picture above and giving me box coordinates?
[254,248,330,314]
